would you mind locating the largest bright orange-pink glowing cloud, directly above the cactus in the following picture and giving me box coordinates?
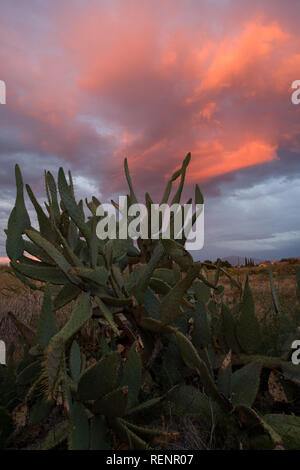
[45,2,299,193]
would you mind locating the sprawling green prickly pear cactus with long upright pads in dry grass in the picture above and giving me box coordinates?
[0,154,300,449]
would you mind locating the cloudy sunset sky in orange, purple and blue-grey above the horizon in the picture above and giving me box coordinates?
[0,0,300,260]
